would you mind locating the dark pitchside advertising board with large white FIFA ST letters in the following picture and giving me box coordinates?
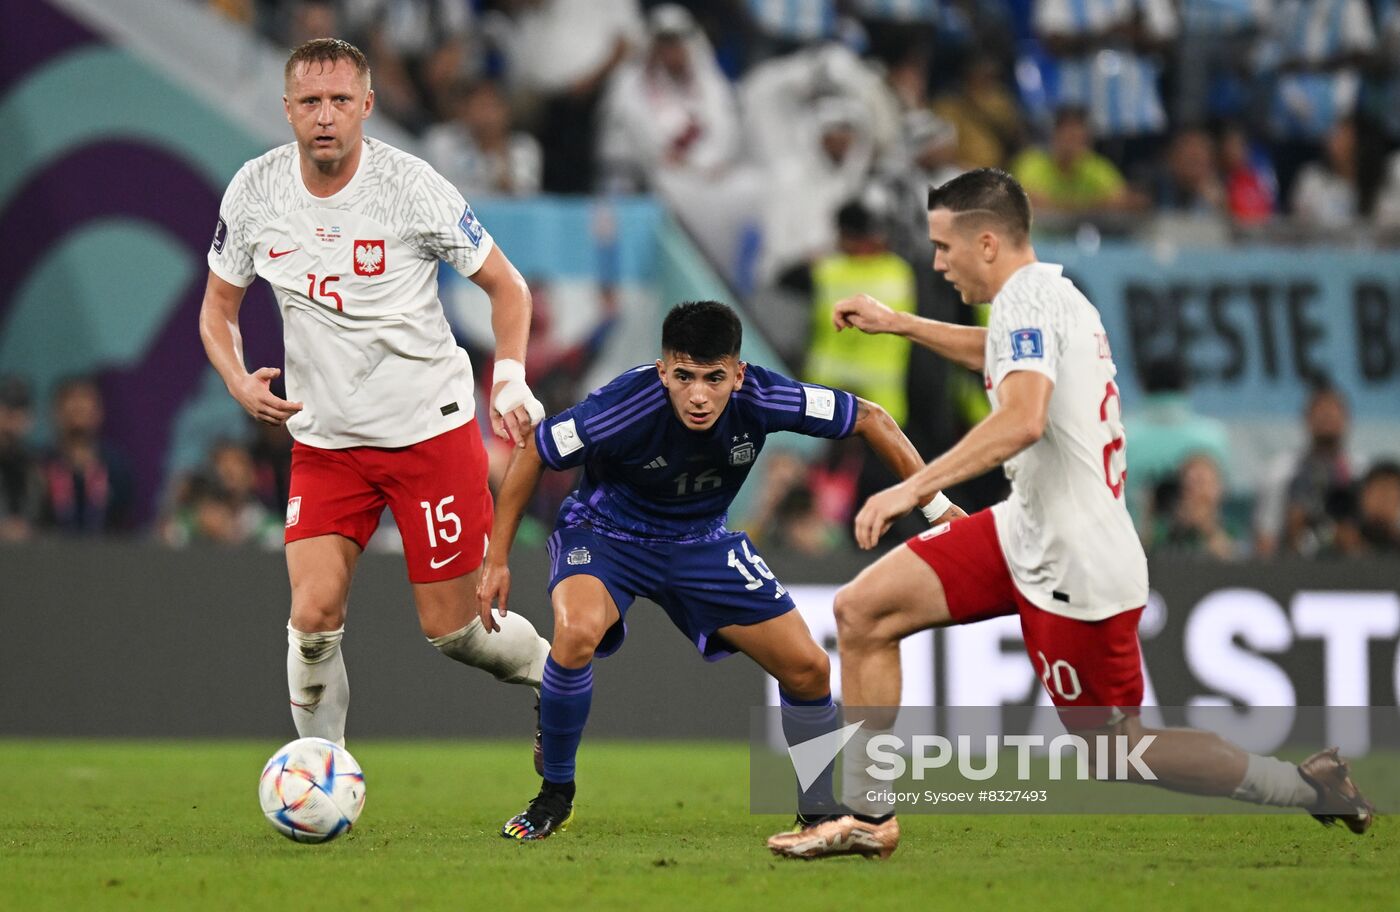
[0,542,1400,748]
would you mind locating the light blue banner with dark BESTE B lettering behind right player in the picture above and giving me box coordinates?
[1036,244,1400,420]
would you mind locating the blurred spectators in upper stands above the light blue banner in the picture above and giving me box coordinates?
[203,0,1400,253]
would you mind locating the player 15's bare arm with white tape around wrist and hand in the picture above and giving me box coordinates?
[472,247,545,447]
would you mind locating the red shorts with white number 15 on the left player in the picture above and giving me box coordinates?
[287,422,491,583]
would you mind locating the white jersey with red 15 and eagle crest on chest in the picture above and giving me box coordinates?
[209,139,493,450]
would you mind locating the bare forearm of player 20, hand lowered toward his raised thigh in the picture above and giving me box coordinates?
[855,370,1054,548]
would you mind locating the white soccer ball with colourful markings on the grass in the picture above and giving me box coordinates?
[258,738,364,842]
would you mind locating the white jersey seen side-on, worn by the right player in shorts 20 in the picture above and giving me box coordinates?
[986,263,1148,621]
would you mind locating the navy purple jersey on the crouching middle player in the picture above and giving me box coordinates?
[535,364,857,542]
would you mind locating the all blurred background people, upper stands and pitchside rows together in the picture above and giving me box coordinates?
[13,0,1400,560]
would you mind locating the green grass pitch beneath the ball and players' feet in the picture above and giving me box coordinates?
[0,740,1400,912]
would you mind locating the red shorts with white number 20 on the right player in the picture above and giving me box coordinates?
[906,510,1142,730]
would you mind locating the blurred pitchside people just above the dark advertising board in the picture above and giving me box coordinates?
[0,358,1400,560]
